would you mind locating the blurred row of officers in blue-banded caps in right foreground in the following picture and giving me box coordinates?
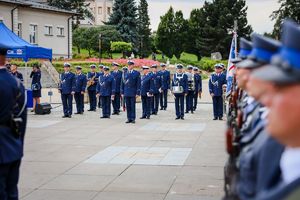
[224,20,300,200]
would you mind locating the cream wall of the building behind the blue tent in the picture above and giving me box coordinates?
[0,3,72,58]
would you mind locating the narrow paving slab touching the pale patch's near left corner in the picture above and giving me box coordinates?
[65,163,128,176]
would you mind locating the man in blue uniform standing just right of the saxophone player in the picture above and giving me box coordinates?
[97,66,116,119]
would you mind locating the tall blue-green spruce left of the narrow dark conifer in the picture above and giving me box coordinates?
[107,0,138,52]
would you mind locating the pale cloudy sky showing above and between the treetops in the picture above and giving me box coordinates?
[148,0,279,33]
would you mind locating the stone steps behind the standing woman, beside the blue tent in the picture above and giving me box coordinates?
[18,61,59,88]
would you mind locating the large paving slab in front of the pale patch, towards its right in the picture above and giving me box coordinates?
[105,165,180,193]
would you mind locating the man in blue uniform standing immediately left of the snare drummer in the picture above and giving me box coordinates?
[159,63,171,110]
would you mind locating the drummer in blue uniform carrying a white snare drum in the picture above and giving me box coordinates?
[172,64,188,120]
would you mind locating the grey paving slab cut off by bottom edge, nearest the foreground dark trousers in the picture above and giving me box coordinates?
[23,190,97,200]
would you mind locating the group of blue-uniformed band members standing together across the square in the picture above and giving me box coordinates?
[59,60,202,123]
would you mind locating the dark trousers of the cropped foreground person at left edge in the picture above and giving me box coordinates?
[0,160,21,200]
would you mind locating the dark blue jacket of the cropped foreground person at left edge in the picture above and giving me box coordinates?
[0,69,27,164]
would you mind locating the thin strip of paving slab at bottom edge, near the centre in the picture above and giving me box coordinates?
[93,192,165,200]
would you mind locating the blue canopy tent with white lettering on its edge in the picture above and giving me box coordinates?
[0,22,52,107]
